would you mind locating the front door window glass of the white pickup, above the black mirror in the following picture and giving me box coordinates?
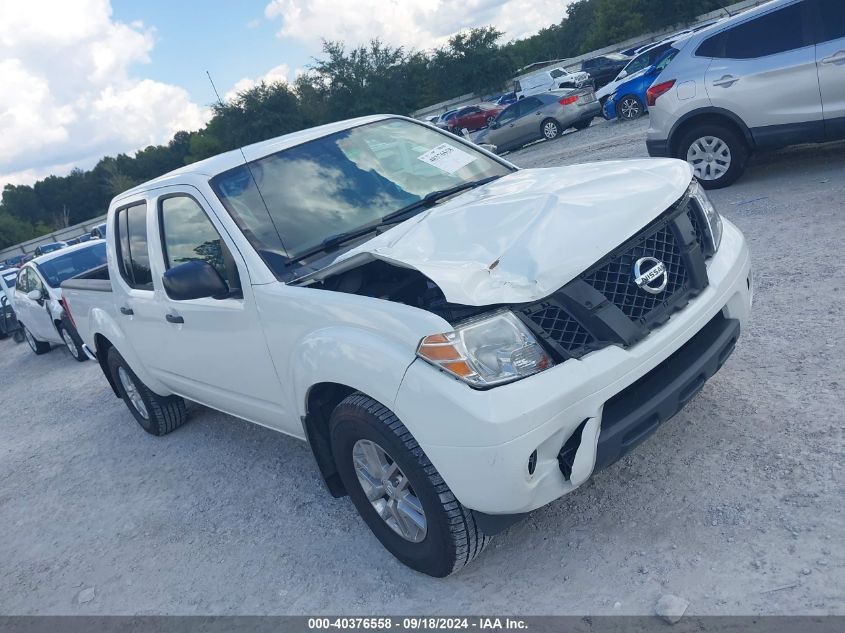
[159,195,241,289]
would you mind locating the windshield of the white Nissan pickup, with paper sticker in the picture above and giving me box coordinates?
[211,119,511,274]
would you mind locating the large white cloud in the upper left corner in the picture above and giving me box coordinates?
[0,0,209,187]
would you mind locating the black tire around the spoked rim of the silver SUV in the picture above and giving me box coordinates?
[675,123,749,189]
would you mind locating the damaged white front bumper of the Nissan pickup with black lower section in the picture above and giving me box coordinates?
[394,221,751,515]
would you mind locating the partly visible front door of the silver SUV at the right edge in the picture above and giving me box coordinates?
[816,0,845,140]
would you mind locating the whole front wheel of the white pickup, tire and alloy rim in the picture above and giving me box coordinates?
[330,393,490,578]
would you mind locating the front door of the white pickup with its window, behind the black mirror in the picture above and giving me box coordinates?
[151,190,286,427]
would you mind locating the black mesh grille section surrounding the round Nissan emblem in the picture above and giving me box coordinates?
[583,223,687,323]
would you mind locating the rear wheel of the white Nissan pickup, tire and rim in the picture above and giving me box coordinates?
[108,347,188,435]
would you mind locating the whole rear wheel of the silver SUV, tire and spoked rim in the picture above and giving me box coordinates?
[676,125,748,189]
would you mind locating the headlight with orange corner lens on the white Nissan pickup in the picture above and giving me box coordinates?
[417,310,554,387]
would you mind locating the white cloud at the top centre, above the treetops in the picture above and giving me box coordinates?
[264,0,573,51]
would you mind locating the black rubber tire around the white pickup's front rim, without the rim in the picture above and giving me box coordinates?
[330,393,490,578]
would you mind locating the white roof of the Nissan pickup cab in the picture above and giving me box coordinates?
[115,114,390,200]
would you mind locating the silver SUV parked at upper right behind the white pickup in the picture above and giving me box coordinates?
[646,0,845,189]
